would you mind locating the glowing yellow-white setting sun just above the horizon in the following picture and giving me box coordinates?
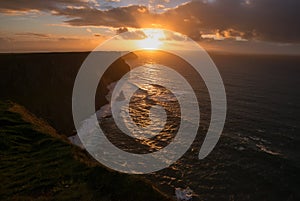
[138,29,165,50]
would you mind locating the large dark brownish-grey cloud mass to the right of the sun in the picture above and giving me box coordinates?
[163,0,300,43]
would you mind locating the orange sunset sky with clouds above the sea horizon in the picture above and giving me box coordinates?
[0,0,300,54]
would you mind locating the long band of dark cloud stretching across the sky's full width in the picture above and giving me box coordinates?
[0,0,300,43]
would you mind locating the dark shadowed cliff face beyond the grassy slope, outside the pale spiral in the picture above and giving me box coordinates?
[0,53,130,135]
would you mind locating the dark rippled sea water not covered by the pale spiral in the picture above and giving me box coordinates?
[101,52,300,200]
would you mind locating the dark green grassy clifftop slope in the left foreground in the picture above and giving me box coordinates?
[0,101,170,201]
